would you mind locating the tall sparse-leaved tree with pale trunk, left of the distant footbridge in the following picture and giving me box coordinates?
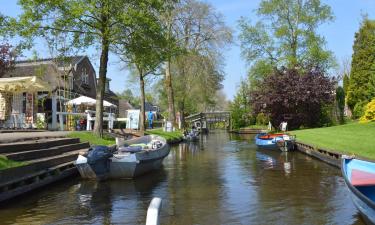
[159,0,232,125]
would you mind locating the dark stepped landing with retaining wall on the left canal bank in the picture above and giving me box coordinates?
[0,132,90,202]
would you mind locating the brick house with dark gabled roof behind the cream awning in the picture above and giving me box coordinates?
[0,56,118,129]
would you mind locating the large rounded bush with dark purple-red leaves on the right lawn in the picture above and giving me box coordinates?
[250,69,336,129]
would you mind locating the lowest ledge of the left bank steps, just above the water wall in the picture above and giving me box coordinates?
[0,148,88,184]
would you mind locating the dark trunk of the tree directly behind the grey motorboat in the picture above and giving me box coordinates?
[94,37,109,137]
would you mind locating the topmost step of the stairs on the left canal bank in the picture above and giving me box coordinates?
[0,138,79,154]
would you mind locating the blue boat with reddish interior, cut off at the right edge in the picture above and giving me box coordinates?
[341,158,375,224]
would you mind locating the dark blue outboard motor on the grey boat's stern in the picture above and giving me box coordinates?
[87,145,113,177]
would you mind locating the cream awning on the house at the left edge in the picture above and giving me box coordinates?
[0,76,51,93]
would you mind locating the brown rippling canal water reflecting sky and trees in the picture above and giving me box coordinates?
[0,131,363,225]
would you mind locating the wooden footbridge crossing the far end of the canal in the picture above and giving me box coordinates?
[185,111,231,131]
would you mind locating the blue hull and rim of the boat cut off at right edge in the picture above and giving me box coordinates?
[341,159,375,224]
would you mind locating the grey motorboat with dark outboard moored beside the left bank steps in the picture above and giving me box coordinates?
[75,135,170,180]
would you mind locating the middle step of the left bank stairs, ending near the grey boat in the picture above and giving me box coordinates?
[5,142,90,161]
